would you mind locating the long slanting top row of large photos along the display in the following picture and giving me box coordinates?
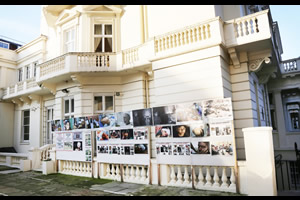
[51,98,233,131]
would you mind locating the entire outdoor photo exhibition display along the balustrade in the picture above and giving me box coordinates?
[51,98,236,166]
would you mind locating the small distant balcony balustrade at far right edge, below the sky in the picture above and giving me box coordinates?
[280,58,300,78]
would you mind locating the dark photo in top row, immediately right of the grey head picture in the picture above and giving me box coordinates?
[132,108,153,127]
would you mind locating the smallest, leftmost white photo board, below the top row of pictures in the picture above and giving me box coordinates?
[55,130,93,162]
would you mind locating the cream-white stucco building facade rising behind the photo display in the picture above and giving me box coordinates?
[0,5,299,195]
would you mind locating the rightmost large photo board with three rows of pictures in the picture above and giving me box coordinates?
[153,98,236,166]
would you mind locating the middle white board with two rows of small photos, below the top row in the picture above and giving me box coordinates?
[94,127,150,165]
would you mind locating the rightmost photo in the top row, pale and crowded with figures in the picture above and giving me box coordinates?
[203,98,233,120]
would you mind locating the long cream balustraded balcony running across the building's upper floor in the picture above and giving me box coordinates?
[3,10,274,99]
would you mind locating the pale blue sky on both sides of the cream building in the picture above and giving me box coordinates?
[0,5,300,60]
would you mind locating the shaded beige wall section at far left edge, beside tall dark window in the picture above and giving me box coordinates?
[0,102,14,147]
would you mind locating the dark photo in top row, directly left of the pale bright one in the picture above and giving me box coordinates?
[152,105,176,125]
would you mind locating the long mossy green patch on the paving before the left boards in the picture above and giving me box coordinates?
[35,173,112,189]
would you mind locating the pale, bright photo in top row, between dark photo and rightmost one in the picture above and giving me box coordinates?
[176,103,202,123]
